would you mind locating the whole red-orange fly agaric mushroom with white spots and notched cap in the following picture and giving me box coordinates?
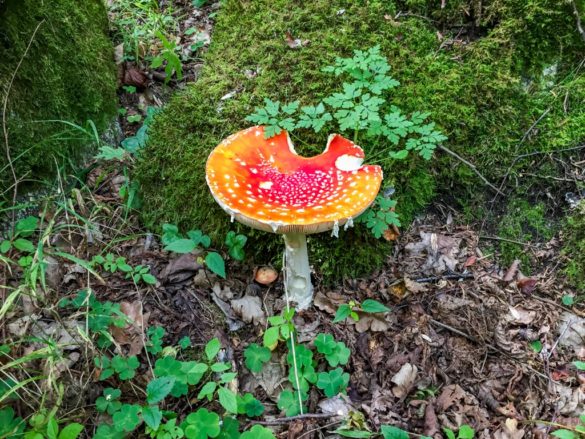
[206,126,382,310]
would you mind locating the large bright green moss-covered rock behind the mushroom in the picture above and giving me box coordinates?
[136,0,583,279]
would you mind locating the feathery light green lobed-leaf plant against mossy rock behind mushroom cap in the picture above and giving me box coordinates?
[246,46,447,238]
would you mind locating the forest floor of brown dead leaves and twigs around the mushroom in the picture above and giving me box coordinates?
[0,0,585,439]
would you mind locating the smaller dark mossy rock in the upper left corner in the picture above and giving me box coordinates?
[0,0,116,194]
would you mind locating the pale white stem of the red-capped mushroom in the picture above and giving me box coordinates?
[283,233,313,310]
